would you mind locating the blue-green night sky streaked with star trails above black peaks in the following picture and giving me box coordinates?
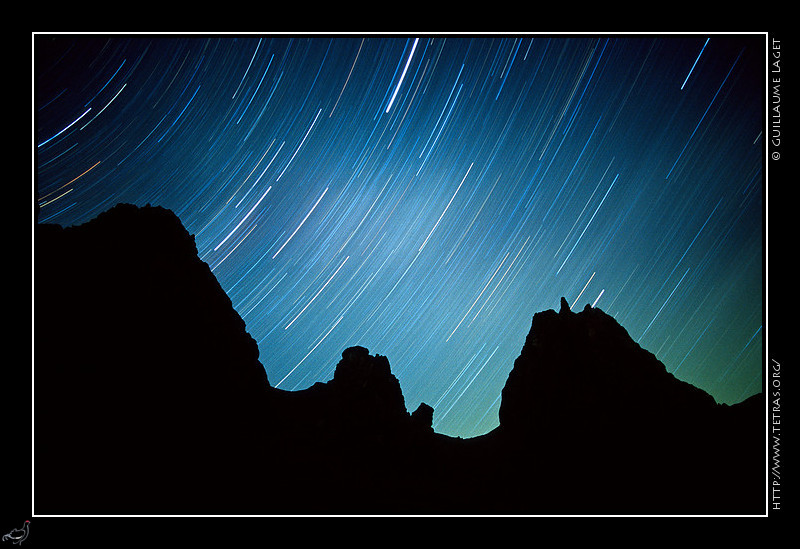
[32,34,766,437]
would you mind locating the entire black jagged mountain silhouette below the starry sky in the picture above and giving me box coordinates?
[33,204,766,515]
